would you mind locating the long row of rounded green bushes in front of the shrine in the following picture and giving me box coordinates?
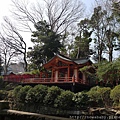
[5,85,120,110]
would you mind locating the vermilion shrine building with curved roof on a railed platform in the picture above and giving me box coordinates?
[4,54,92,92]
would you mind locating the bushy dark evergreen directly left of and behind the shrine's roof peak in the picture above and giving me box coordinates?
[28,21,63,68]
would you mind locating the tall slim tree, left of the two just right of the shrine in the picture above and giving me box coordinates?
[90,6,106,62]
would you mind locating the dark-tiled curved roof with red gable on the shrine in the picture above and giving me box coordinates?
[43,54,92,68]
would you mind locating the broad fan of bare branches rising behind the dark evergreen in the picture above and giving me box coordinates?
[12,0,84,33]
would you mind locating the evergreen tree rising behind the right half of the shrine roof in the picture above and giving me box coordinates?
[73,18,92,58]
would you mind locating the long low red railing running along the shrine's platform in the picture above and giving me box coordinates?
[4,75,89,85]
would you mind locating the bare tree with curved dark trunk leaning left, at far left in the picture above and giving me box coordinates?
[2,17,27,71]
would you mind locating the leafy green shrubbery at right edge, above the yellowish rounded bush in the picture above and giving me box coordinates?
[97,59,120,85]
